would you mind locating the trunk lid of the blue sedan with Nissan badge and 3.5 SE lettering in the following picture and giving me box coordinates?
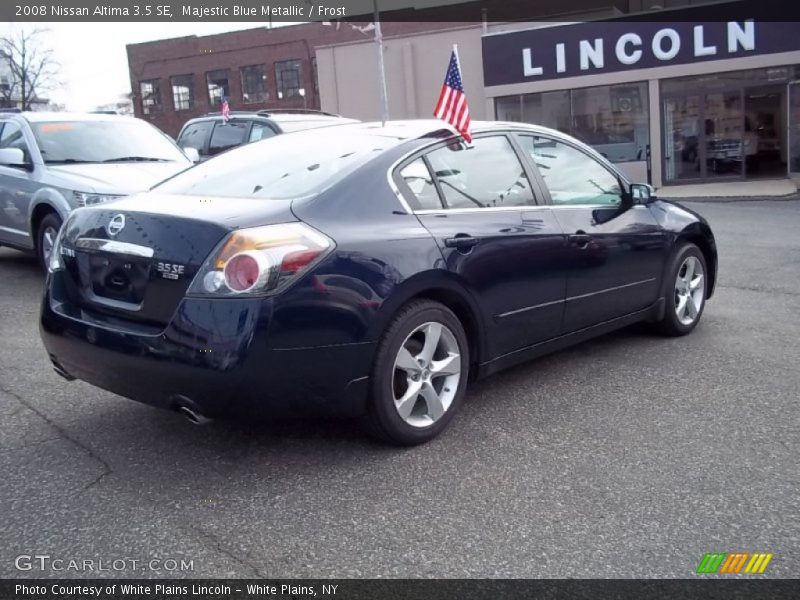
[61,193,297,325]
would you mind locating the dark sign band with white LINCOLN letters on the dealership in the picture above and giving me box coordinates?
[483,19,800,86]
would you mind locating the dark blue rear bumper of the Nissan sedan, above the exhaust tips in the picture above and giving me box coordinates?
[40,276,374,419]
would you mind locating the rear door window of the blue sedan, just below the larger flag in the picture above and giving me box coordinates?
[428,135,536,208]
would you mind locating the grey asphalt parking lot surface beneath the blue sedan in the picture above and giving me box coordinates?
[0,201,800,578]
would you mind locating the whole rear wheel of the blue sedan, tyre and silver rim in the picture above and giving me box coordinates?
[368,300,469,446]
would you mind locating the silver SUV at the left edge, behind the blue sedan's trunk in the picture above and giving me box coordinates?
[0,112,197,266]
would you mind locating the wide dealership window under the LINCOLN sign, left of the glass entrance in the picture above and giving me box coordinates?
[495,82,650,162]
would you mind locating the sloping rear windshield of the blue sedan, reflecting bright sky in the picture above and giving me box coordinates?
[155,131,391,199]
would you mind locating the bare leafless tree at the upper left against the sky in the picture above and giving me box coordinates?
[0,29,60,110]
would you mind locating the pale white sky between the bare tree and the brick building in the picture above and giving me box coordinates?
[0,21,280,111]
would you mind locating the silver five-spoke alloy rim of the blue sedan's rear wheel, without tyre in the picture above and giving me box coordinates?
[392,322,461,428]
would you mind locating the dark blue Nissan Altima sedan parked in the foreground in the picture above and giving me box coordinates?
[41,121,717,444]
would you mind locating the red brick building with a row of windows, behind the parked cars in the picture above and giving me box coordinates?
[127,22,462,136]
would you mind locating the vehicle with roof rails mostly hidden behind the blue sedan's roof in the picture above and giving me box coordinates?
[178,109,358,161]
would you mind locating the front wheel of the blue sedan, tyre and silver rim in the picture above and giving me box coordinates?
[657,243,707,336]
